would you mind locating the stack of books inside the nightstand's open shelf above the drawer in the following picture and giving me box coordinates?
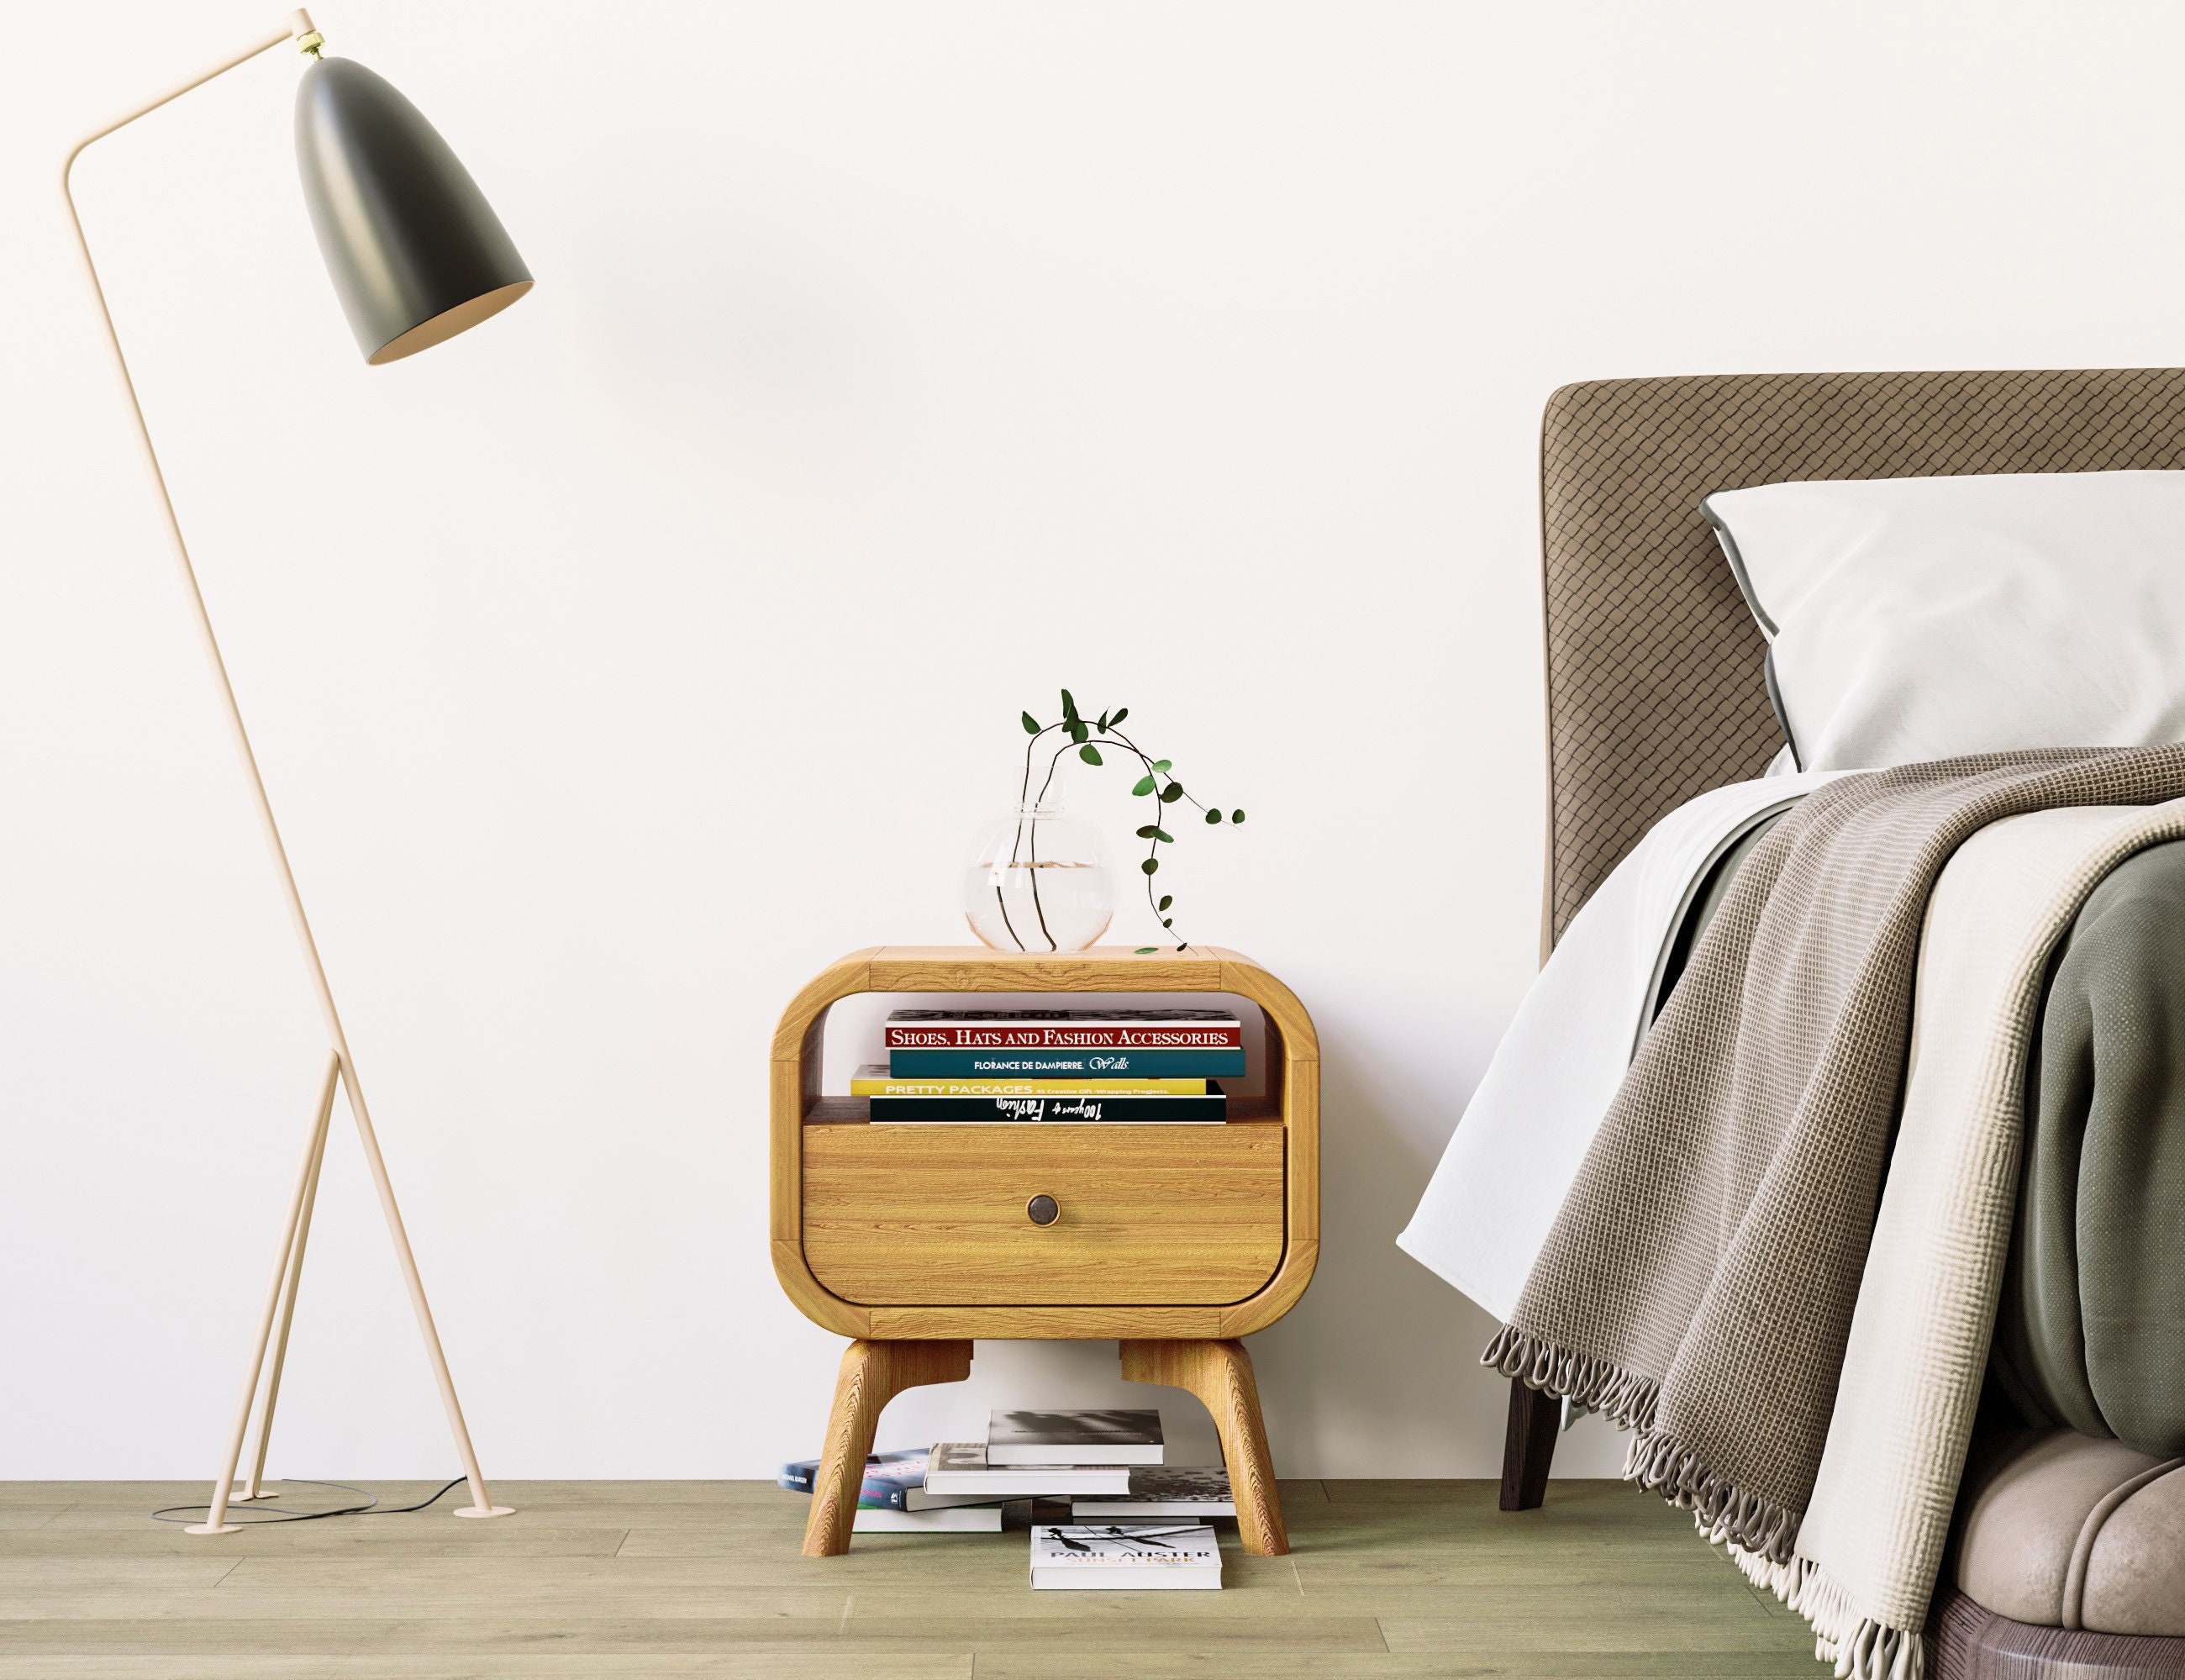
[869,1009,1243,1125]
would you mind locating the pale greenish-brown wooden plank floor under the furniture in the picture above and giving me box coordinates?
[0,1481,1827,1680]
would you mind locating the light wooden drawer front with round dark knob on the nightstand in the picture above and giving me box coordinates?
[802,1123,1285,1306]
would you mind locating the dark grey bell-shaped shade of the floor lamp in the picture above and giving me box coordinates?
[295,59,531,367]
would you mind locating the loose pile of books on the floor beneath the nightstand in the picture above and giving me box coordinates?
[780,1411,1237,1546]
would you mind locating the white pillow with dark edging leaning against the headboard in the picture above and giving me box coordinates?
[1700,471,2185,769]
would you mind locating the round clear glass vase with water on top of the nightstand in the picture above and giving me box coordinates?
[964,804,1114,951]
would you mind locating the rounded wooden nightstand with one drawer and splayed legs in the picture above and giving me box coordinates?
[771,946,1319,1557]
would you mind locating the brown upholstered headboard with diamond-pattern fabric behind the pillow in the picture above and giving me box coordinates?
[1540,367,2185,948]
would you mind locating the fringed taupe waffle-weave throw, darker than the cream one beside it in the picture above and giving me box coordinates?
[1483,747,2185,1590]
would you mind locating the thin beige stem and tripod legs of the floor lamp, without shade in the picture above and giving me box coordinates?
[61,11,509,1534]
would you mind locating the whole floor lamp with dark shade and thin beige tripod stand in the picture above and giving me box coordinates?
[61,11,531,1534]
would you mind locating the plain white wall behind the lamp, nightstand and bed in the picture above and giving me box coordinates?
[0,0,2185,1477]
